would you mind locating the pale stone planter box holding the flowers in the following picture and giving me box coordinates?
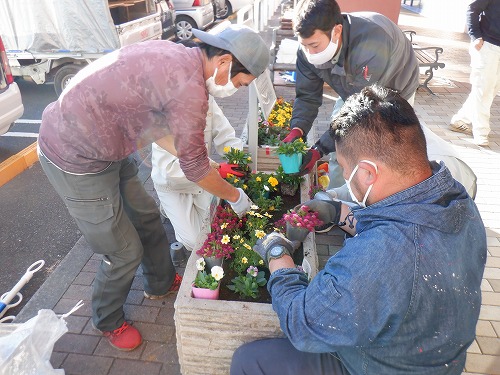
[174,178,318,375]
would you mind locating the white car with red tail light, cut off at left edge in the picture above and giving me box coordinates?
[0,37,24,135]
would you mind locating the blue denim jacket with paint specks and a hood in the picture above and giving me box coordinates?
[268,162,487,375]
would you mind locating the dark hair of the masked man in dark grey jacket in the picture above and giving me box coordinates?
[293,0,343,38]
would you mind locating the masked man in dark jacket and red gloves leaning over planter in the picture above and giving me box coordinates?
[284,0,419,187]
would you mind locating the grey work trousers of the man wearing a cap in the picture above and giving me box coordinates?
[39,154,175,331]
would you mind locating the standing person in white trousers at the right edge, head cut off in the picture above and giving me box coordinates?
[450,0,500,146]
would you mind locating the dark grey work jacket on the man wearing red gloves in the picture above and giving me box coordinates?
[290,12,419,154]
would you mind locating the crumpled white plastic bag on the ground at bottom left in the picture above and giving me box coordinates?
[0,310,68,375]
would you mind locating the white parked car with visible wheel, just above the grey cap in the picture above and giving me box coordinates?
[172,0,215,40]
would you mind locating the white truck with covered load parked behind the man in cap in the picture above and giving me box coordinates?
[0,0,162,95]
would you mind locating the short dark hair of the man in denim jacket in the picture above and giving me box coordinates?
[330,85,429,175]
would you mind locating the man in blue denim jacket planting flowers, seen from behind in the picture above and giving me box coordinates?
[231,86,487,375]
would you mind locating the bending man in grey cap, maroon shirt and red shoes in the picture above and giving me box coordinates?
[38,26,269,350]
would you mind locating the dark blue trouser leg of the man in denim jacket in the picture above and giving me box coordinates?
[230,338,349,375]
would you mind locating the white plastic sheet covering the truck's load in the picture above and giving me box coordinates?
[0,0,120,55]
